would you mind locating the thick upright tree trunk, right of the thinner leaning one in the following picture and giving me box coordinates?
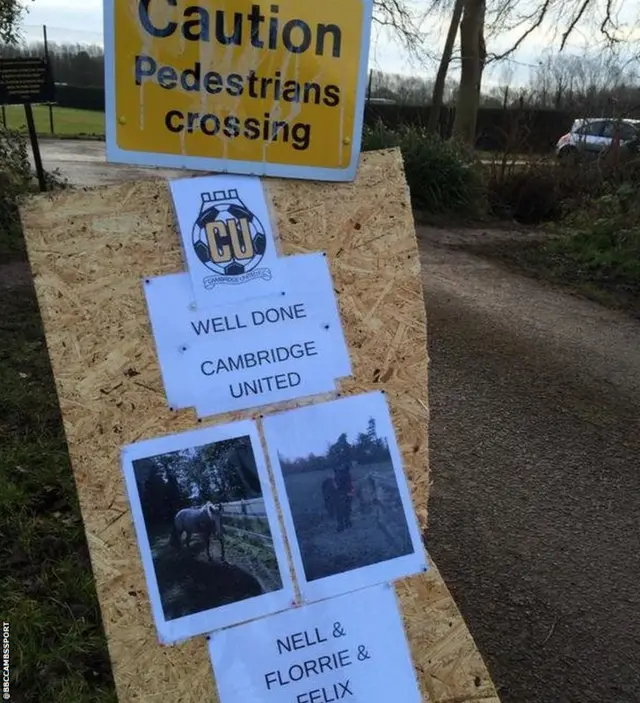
[453,0,486,146]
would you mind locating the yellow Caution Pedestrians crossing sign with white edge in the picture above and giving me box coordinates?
[105,0,372,180]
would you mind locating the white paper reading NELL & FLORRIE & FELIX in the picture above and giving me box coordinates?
[209,585,422,703]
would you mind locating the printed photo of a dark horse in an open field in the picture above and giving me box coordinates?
[265,394,415,582]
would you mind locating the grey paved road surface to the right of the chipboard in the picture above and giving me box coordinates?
[421,230,640,703]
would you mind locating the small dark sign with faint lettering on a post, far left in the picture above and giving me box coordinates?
[0,58,54,105]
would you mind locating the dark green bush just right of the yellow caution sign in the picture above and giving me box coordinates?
[362,122,485,215]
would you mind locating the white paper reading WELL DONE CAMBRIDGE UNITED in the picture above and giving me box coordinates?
[144,253,351,416]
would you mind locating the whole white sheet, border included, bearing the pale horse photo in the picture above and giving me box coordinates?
[122,420,294,644]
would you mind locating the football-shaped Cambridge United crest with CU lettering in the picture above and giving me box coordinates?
[192,189,271,290]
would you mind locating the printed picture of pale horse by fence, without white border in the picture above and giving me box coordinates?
[126,436,282,621]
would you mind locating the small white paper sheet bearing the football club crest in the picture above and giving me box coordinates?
[169,175,284,309]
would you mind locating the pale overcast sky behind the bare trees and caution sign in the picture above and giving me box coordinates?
[15,0,640,89]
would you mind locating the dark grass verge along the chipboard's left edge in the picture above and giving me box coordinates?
[0,268,116,703]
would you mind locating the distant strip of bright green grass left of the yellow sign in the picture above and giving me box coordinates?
[5,105,104,138]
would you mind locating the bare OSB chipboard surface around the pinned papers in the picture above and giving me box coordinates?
[21,150,498,703]
